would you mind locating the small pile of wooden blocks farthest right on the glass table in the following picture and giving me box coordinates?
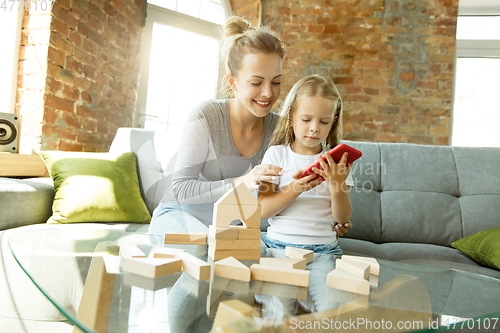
[326,255,380,295]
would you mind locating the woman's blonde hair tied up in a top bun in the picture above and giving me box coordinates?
[221,16,285,98]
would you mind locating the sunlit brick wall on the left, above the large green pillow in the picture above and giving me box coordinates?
[16,0,145,153]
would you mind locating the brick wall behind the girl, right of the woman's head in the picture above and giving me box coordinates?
[262,0,458,145]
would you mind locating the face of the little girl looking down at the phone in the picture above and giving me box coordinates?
[291,96,337,155]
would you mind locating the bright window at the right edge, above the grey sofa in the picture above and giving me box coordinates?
[451,0,500,147]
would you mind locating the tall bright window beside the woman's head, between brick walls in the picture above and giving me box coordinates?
[137,0,230,137]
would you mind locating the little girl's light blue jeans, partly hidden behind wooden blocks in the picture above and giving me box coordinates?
[262,235,342,315]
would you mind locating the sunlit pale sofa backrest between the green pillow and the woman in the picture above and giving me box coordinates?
[109,127,179,214]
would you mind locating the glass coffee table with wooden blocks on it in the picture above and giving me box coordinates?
[8,225,500,333]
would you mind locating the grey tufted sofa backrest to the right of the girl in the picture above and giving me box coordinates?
[345,141,500,246]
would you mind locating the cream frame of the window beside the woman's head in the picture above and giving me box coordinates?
[134,0,229,128]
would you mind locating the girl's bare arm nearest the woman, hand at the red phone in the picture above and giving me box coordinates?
[259,170,322,219]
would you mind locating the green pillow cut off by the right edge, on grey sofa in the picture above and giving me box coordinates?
[451,227,500,269]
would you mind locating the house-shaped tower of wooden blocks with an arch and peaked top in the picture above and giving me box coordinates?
[208,183,261,260]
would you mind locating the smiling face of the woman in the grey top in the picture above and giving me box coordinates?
[227,52,282,117]
